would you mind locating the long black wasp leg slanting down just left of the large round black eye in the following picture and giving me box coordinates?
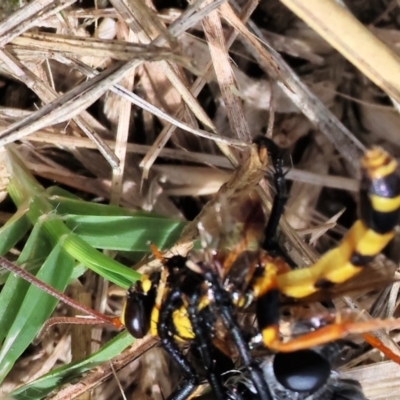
[204,271,272,400]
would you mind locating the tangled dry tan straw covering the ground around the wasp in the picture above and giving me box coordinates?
[0,0,400,400]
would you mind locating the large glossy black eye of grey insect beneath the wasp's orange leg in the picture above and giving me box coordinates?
[273,350,331,393]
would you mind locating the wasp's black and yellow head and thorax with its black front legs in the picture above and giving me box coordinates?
[124,256,271,400]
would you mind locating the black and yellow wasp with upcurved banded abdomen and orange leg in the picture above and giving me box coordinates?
[119,138,400,400]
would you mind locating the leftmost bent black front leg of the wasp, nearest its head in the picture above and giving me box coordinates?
[157,288,198,400]
